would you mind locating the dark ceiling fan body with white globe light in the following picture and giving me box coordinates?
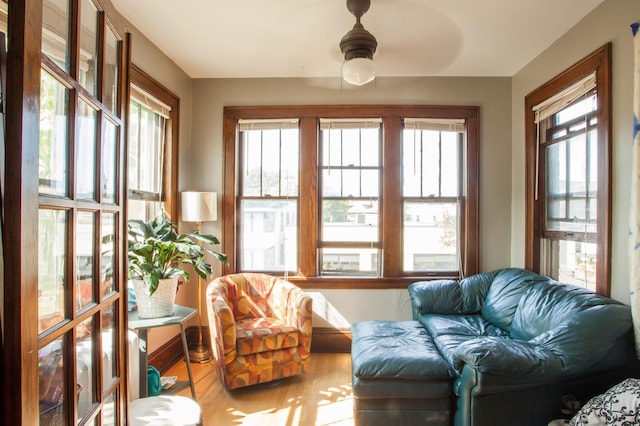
[340,0,378,86]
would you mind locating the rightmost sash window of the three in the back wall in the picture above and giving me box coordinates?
[402,118,464,273]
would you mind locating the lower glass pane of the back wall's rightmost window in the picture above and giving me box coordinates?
[403,202,459,271]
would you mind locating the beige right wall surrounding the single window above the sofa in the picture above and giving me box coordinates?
[511,0,640,303]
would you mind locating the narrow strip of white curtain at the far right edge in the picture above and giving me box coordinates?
[629,22,640,357]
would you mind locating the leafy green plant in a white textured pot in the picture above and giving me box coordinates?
[128,214,227,318]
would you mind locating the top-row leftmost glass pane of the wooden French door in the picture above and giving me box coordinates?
[42,0,69,72]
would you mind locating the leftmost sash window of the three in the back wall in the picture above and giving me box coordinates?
[237,120,300,272]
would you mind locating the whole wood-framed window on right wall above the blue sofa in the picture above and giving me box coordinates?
[526,45,611,295]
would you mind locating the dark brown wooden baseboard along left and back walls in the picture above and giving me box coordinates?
[148,326,351,374]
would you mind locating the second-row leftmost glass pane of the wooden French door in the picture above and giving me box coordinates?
[38,70,69,195]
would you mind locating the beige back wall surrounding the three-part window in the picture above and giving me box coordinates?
[189,76,511,327]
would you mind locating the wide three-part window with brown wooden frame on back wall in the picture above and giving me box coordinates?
[223,106,479,288]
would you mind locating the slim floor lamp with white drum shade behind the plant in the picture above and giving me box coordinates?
[181,191,218,363]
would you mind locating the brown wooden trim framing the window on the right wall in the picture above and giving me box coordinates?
[525,43,612,296]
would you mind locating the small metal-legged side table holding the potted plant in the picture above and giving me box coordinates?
[128,305,198,399]
